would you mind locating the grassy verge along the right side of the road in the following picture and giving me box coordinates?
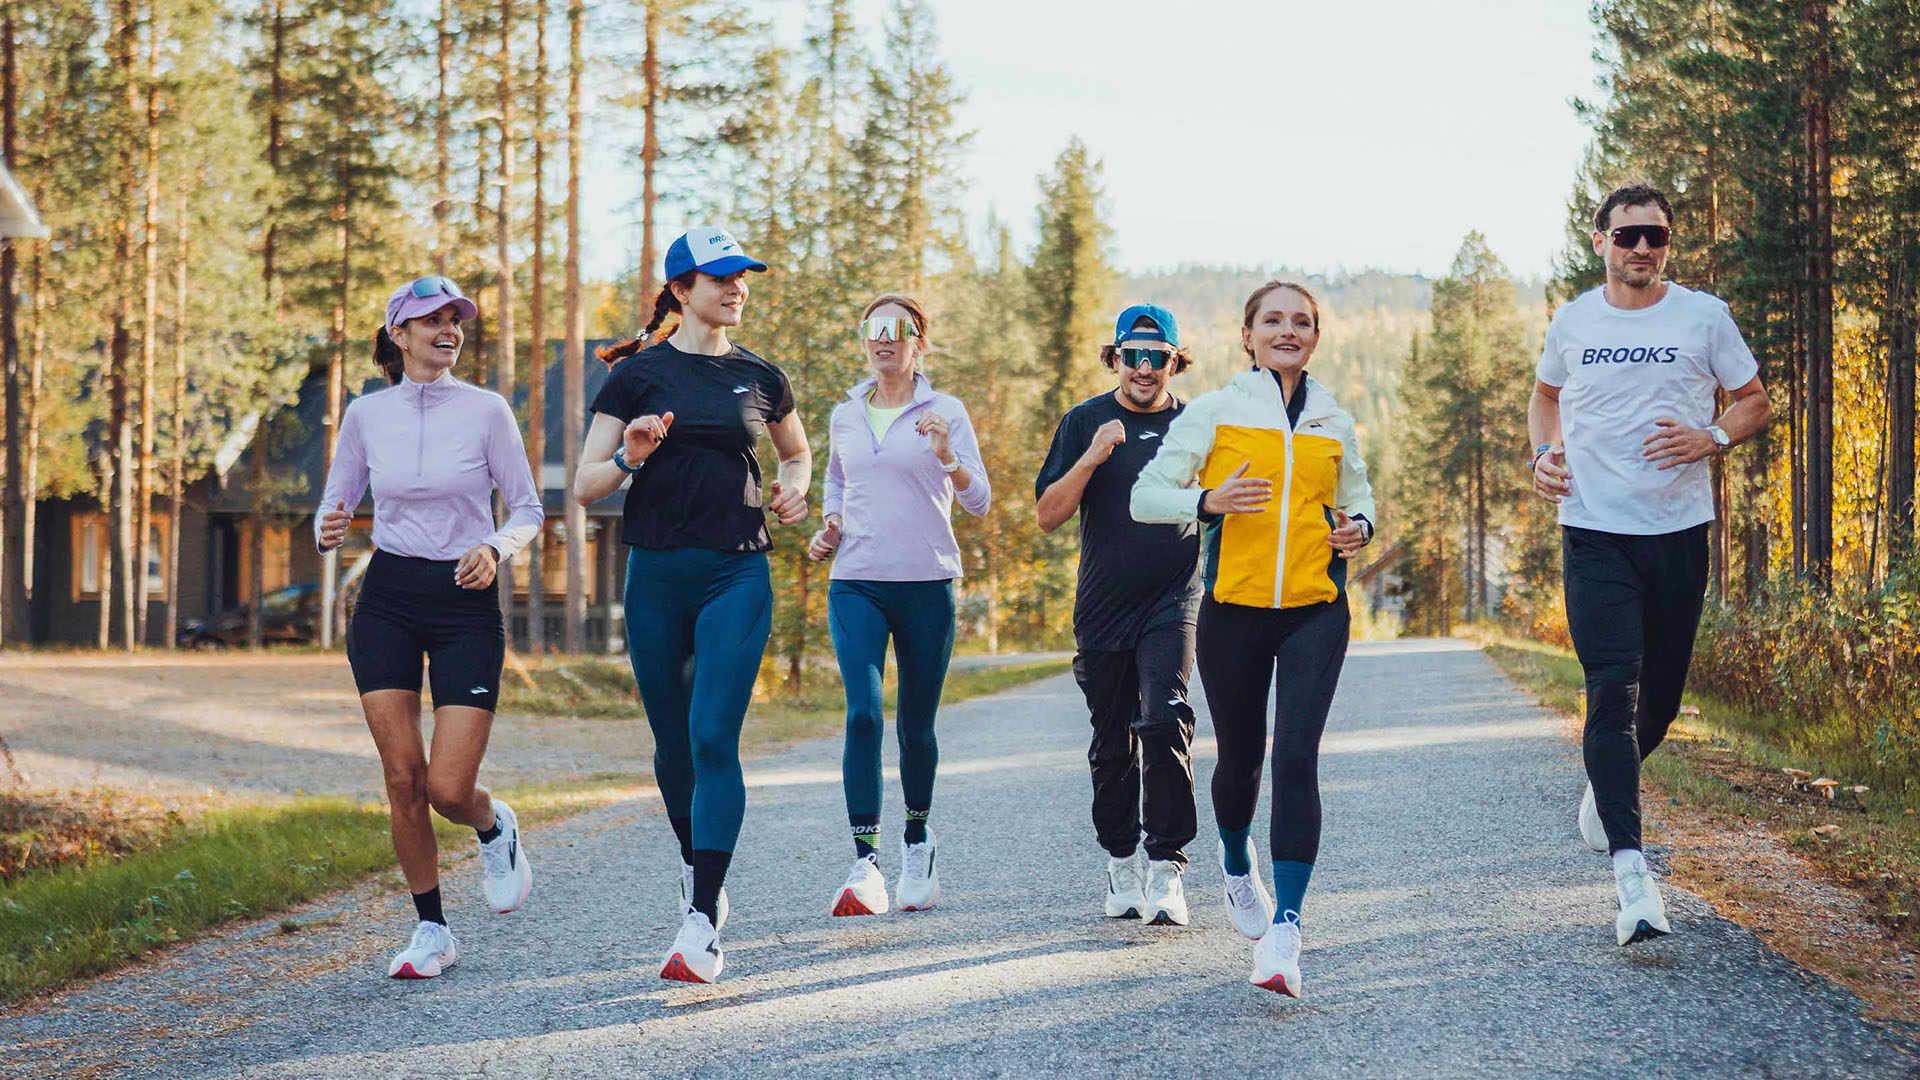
[1482,638,1920,1020]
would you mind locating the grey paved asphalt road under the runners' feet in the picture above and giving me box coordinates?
[0,642,1920,1080]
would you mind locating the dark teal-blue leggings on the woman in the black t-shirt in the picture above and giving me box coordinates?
[626,548,774,863]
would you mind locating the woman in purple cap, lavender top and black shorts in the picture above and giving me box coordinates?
[313,275,545,978]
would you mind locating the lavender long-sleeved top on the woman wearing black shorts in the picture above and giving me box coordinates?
[313,373,547,563]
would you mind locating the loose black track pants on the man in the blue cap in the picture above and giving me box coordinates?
[1073,623,1200,865]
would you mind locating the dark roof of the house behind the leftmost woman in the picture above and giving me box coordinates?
[209,340,624,517]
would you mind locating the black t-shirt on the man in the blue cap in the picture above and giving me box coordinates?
[1033,394,1200,651]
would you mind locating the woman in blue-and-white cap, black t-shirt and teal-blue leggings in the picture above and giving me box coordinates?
[574,227,812,982]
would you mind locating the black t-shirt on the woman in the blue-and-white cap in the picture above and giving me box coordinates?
[593,342,793,552]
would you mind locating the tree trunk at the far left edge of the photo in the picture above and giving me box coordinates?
[0,4,22,642]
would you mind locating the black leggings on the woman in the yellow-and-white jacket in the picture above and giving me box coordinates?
[1198,596,1350,863]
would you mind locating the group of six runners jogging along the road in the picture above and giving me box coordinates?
[315,176,1770,997]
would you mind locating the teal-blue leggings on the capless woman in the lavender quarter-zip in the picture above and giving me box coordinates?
[828,580,954,824]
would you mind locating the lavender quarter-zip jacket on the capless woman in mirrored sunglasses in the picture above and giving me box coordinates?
[820,373,993,580]
